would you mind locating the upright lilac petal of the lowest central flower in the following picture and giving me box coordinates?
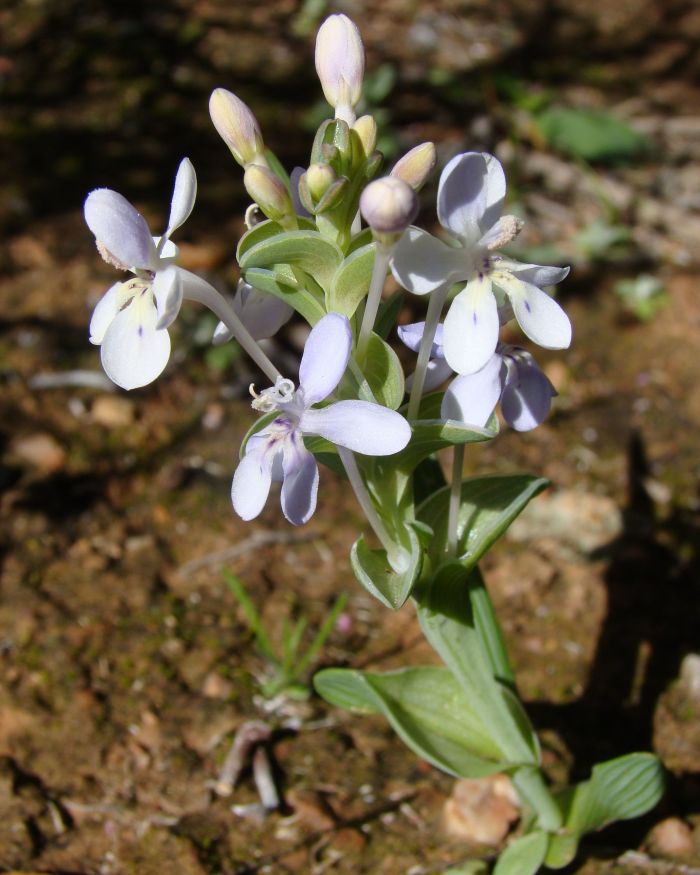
[299,313,352,406]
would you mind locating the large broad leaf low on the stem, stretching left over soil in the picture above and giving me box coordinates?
[314,667,507,777]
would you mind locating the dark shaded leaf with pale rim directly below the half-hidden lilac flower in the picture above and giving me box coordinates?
[391,392,498,471]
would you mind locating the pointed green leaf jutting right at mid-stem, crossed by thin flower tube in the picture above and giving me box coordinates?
[412,476,547,568]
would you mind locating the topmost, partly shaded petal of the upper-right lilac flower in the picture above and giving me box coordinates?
[437,152,506,244]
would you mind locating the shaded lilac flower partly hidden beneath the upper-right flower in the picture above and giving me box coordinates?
[399,322,557,431]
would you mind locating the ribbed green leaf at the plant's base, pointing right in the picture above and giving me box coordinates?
[566,753,664,835]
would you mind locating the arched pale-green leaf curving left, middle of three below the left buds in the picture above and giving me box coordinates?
[238,229,343,289]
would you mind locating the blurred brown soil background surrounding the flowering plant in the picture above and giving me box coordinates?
[0,0,700,875]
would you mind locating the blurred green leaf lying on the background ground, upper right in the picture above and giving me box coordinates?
[536,107,651,163]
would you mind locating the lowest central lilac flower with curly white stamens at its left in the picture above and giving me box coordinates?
[231,313,411,525]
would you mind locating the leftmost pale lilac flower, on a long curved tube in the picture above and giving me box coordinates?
[85,158,198,389]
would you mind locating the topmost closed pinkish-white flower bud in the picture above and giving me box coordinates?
[316,15,365,124]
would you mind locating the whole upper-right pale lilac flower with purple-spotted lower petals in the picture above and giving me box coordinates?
[392,152,571,374]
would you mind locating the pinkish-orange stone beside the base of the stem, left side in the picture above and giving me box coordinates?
[443,775,520,847]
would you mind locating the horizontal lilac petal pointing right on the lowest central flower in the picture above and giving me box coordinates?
[299,401,411,456]
